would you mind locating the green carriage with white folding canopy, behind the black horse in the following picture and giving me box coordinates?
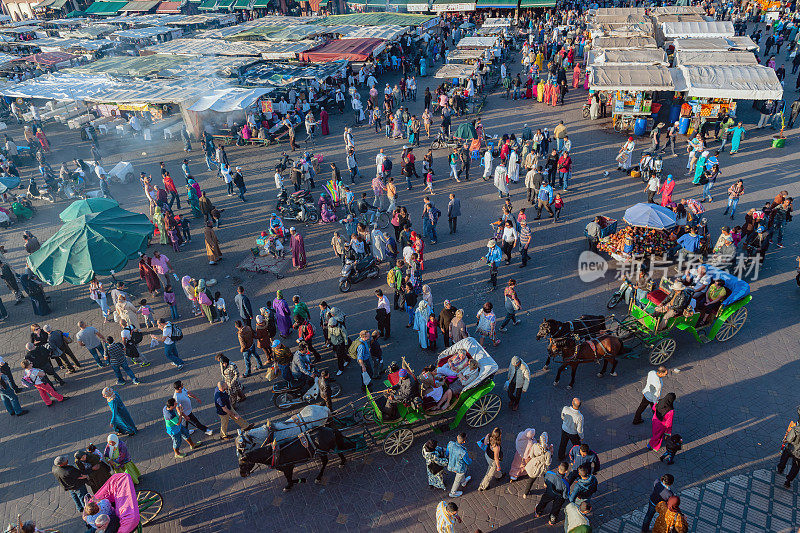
[363,337,502,455]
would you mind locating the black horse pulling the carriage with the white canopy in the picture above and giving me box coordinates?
[234,426,355,492]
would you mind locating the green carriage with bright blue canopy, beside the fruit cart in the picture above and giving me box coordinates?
[611,265,752,365]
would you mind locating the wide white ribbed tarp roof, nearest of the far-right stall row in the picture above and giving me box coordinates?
[675,65,783,100]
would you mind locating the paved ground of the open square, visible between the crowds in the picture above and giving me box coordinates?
[0,42,800,532]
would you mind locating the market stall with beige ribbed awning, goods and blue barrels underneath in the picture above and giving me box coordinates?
[589,65,675,135]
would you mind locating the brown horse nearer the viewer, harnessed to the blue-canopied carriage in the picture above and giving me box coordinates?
[545,335,625,389]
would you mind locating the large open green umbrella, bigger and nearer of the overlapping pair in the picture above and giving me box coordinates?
[28,209,153,285]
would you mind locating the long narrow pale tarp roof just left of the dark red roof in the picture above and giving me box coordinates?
[147,38,317,59]
